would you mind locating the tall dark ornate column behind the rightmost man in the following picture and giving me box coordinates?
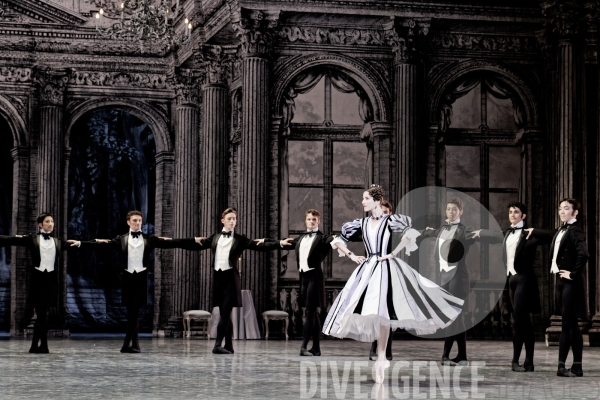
[542,0,587,345]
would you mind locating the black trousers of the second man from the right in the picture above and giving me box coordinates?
[508,274,535,365]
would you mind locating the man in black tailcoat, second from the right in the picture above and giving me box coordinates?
[473,202,554,372]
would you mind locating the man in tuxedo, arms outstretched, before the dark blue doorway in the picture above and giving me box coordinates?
[75,211,185,353]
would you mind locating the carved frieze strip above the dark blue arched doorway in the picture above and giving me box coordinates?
[69,69,167,89]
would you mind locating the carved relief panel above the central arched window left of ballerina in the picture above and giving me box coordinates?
[278,26,386,46]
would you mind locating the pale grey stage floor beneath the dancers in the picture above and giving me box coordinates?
[0,335,600,400]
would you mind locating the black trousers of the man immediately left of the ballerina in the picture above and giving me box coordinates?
[300,269,321,352]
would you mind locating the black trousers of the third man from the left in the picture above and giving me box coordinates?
[214,269,238,351]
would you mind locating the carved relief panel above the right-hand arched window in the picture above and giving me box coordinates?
[430,32,540,53]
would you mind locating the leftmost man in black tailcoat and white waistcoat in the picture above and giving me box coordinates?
[0,212,79,353]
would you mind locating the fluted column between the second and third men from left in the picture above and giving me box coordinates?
[165,71,200,336]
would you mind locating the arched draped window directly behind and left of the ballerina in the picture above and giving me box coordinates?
[282,67,373,281]
